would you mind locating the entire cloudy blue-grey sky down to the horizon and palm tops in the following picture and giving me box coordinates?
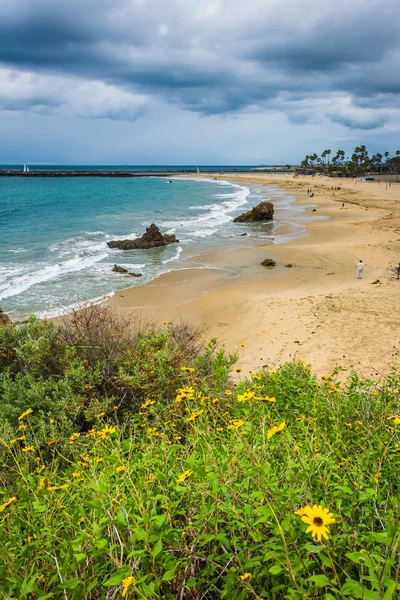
[0,0,400,165]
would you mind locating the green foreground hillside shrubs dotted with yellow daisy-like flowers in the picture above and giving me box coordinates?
[0,307,400,600]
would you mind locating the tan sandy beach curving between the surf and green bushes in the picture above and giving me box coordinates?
[109,173,400,377]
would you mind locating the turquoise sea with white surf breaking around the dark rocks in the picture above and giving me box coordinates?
[0,167,305,318]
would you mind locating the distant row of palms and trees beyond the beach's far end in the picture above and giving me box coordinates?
[301,145,400,177]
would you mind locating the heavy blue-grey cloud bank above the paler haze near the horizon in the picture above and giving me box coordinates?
[0,0,400,128]
